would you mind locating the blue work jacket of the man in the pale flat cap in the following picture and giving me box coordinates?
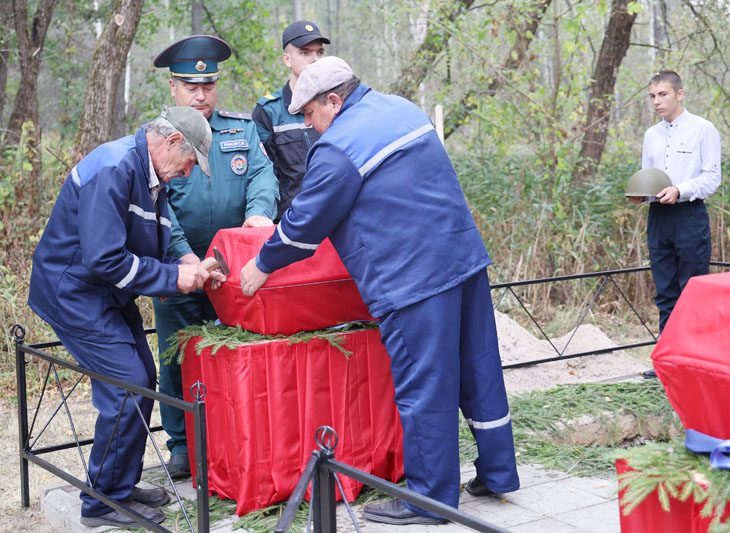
[256,84,490,316]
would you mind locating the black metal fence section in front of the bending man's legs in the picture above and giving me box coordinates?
[11,324,210,533]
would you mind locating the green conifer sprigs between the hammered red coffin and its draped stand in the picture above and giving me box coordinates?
[160,322,378,364]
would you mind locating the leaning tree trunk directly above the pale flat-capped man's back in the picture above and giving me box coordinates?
[388,0,474,100]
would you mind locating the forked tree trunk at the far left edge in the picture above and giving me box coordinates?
[6,0,56,160]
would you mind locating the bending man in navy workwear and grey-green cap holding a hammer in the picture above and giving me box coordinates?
[28,107,225,527]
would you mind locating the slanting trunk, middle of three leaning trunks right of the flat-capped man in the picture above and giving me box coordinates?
[444,0,551,138]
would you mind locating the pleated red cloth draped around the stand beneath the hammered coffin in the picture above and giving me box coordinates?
[182,329,403,515]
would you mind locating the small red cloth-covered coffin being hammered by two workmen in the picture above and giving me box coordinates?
[206,226,372,335]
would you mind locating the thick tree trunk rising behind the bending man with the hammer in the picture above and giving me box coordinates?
[76,0,144,155]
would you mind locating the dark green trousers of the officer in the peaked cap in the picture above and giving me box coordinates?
[153,291,213,455]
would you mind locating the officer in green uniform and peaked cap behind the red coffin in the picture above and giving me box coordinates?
[154,35,279,479]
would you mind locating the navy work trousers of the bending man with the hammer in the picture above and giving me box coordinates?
[53,316,155,516]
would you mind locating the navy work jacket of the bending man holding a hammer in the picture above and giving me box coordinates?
[28,129,178,342]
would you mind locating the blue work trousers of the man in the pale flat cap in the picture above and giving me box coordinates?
[380,271,519,515]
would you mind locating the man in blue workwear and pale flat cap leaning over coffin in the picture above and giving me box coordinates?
[241,57,519,525]
